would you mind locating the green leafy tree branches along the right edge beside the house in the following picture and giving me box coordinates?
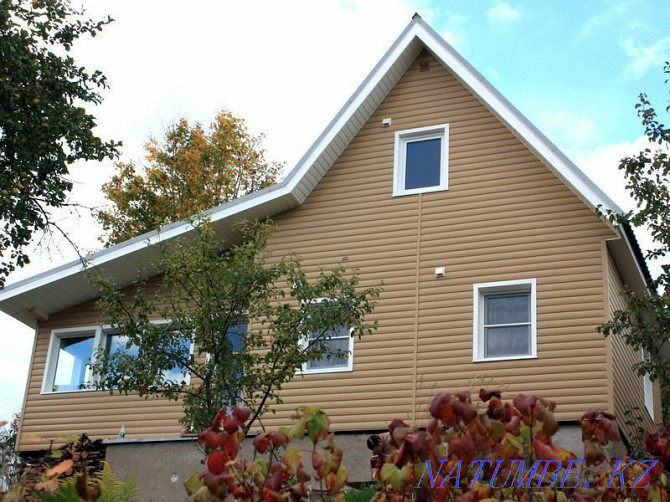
[598,63,670,423]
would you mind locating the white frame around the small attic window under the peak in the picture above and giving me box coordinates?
[393,124,449,197]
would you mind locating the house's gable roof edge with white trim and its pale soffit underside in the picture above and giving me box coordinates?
[0,14,645,325]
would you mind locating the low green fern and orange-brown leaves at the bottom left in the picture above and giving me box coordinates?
[41,462,138,502]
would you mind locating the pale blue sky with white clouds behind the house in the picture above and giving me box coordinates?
[0,0,670,419]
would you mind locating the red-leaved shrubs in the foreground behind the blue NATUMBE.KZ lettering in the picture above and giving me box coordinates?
[186,389,670,502]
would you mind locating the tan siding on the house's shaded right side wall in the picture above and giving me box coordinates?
[608,255,661,435]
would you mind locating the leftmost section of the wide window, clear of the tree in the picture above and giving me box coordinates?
[42,327,97,392]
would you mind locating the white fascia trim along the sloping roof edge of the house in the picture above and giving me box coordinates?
[0,15,640,322]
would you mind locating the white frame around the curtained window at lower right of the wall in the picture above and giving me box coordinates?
[472,279,537,362]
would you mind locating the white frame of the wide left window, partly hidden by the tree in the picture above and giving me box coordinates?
[41,319,195,394]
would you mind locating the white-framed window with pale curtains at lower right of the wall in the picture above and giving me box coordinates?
[473,279,537,361]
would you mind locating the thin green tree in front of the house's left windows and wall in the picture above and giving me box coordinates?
[92,222,380,430]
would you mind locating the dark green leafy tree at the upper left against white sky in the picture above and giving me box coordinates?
[0,0,119,287]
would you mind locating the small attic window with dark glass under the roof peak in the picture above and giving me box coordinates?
[393,124,449,195]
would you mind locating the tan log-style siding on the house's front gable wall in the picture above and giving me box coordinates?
[21,53,615,449]
